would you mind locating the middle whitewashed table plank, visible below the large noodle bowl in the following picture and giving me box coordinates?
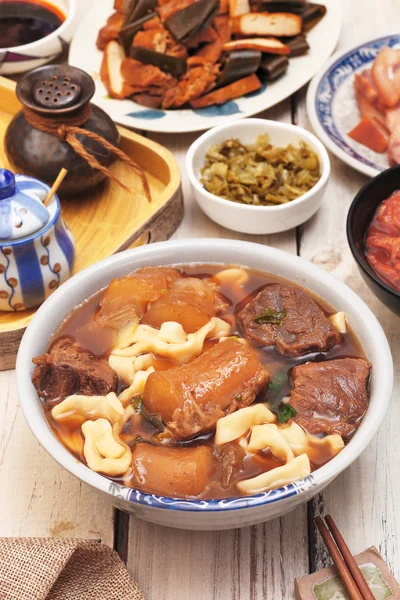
[123,101,309,600]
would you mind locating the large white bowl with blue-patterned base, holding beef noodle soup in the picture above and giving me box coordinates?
[17,239,393,530]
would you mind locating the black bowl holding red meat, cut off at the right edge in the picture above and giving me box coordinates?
[347,165,400,315]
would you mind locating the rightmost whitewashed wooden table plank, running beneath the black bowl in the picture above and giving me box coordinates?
[298,0,400,577]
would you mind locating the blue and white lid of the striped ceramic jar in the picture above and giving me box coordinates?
[0,169,50,241]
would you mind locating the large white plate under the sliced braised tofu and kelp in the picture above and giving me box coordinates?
[69,0,342,133]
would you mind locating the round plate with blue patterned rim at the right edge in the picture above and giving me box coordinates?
[307,33,400,177]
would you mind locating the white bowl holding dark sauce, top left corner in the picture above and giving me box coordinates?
[0,0,77,75]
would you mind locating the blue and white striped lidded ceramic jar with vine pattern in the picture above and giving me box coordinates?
[0,169,75,311]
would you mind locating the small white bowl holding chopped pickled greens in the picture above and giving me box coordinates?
[186,119,331,234]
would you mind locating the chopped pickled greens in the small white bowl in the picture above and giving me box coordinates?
[201,134,321,206]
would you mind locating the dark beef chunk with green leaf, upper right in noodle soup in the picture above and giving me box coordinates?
[237,283,342,356]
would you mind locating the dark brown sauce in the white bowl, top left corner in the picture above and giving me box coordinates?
[0,0,65,48]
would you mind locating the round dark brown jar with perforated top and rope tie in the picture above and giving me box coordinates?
[5,65,119,198]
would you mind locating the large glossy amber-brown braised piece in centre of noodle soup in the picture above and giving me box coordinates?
[143,338,269,438]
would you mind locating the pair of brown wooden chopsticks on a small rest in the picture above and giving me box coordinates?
[315,515,375,600]
